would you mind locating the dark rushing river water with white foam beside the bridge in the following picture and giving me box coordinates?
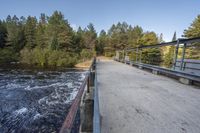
[0,69,86,133]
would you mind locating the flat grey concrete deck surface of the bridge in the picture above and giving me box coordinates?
[97,61,200,133]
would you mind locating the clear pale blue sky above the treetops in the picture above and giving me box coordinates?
[0,0,200,41]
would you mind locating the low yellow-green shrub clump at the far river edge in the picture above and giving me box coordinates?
[20,48,77,67]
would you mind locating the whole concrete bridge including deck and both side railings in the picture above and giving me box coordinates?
[60,38,200,133]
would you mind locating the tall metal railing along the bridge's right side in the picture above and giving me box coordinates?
[115,37,200,82]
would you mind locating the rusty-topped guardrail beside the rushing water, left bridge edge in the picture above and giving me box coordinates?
[60,58,100,133]
